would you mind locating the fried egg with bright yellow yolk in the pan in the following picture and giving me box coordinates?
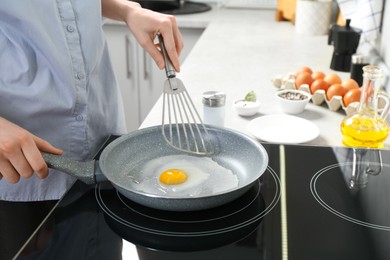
[133,155,238,197]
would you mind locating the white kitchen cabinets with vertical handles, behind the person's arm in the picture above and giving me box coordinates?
[103,23,204,132]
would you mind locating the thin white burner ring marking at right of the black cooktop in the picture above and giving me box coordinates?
[310,162,390,231]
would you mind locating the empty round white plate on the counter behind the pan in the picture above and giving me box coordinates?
[248,114,320,144]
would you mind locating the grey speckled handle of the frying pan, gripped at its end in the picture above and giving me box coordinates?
[42,152,100,184]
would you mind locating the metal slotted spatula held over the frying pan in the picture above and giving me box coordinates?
[158,34,214,155]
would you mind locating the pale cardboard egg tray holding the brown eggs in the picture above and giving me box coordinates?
[272,74,359,115]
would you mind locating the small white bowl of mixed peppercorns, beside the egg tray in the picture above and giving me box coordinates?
[276,89,311,114]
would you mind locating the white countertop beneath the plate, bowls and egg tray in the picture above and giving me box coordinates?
[141,6,388,146]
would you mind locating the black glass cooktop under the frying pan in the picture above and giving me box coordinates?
[9,144,390,260]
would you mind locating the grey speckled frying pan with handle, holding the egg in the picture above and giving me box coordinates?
[43,126,268,211]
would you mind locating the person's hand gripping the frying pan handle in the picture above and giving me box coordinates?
[0,117,63,183]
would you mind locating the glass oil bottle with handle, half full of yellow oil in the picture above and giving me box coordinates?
[341,65,390,148]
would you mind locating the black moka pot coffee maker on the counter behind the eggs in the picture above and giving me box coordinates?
[328,19,362,71]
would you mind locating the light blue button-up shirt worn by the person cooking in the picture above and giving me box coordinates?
[0,0,126,201]
